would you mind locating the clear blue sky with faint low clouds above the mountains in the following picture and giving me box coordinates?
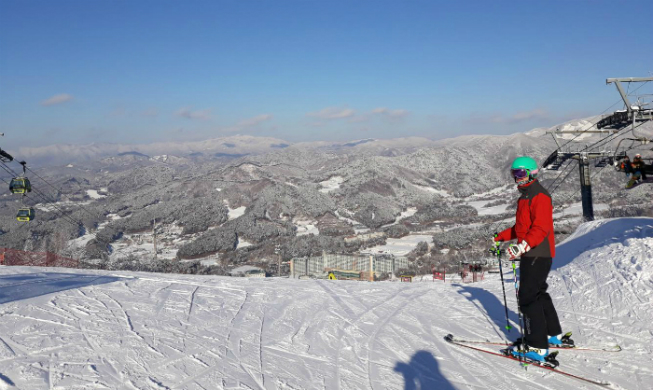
[0,0,653,149]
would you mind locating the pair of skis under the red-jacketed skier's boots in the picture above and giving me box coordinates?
[444,334,621,388]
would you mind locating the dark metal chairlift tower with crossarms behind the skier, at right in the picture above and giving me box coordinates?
[542,77,653,221]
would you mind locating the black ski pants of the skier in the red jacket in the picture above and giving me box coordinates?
[519,257,562,348]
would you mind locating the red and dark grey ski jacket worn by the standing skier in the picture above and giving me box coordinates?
[495,180,555,258]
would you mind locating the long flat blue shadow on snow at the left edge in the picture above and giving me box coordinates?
[0,272,120,304]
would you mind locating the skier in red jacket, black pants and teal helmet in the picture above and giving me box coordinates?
[494,156,573,361]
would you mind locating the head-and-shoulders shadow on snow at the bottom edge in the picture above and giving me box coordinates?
[394,351,455,390]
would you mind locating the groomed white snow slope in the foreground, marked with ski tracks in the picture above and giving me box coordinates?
[0,218,653,390]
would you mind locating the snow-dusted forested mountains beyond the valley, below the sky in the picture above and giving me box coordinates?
[0,119,653,264]
